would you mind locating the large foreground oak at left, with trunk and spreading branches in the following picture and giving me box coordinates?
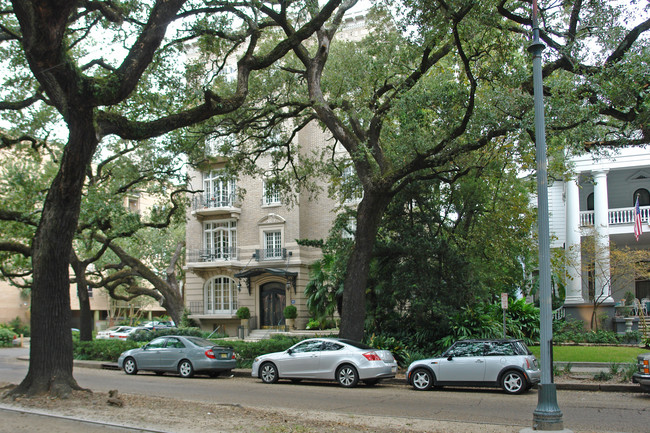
[0,0,344,395]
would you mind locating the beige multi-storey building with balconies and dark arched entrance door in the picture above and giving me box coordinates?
[185,120,336,336]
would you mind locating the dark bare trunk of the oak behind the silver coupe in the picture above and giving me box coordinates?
[339,192,391,341]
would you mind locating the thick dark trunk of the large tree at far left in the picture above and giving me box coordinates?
[12,110,97,397]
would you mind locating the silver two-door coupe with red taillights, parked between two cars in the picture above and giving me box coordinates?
[251,338,397,388]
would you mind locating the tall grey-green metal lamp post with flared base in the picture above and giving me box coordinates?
[528,0,564,431]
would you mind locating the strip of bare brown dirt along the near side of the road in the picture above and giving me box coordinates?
[0,383,520,433]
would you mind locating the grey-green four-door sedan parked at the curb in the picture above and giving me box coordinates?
[117,335,237,377]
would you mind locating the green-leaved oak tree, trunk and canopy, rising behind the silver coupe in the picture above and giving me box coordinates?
[202,0,650,340]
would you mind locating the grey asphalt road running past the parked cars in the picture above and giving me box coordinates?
[0,349,650,433]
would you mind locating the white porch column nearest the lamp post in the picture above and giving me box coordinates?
[564,176,585,305]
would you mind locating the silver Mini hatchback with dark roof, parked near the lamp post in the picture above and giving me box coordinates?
[406,339,541,394]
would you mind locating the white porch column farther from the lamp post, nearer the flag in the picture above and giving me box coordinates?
[592,169,614,303]
